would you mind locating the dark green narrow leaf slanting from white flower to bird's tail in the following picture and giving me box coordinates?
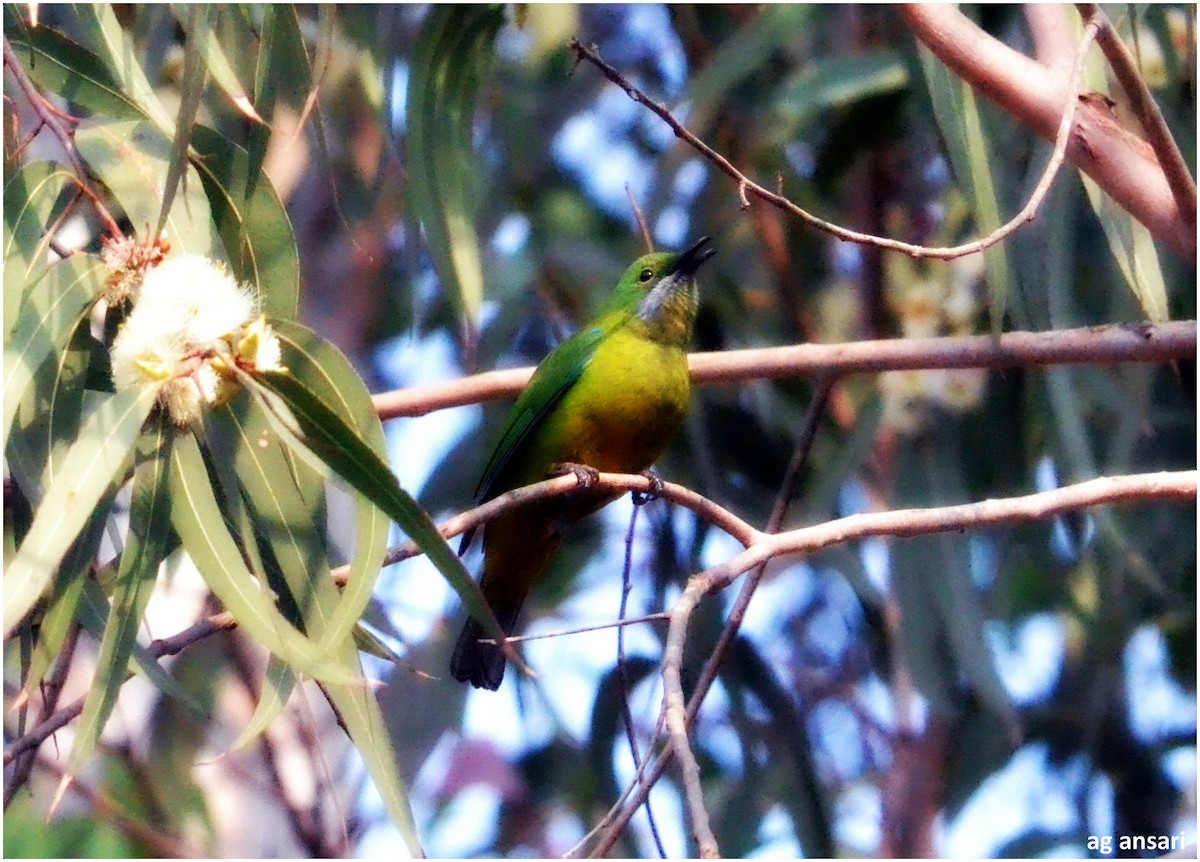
[241,372,503,653]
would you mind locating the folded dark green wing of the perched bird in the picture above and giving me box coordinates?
[475,325,612,503]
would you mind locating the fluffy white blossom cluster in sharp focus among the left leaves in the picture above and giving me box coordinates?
[112,255,282,425]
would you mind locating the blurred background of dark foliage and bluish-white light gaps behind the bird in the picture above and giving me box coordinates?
[5,5,1196,856]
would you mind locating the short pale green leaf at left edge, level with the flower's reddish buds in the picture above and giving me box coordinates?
[4,162,76,339]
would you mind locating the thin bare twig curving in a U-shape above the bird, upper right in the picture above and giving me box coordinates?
[569,22,1099,261]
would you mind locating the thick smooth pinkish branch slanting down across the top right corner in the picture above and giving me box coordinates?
[900,4,1196,262]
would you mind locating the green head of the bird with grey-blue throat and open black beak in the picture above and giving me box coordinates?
[607,237,715,347]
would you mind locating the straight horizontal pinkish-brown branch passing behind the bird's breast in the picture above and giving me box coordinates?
[372,321,1196,419]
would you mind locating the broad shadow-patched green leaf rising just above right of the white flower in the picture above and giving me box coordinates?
[192,126,300,321]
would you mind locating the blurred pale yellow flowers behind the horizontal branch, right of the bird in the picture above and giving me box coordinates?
[878,255,988,433]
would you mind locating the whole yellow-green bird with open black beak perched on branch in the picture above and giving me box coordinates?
[450,237,714,692]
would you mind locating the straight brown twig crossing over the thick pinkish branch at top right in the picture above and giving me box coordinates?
[1075,4,1196,231]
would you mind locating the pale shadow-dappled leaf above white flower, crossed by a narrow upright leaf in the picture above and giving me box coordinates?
[74,120,220,257]
